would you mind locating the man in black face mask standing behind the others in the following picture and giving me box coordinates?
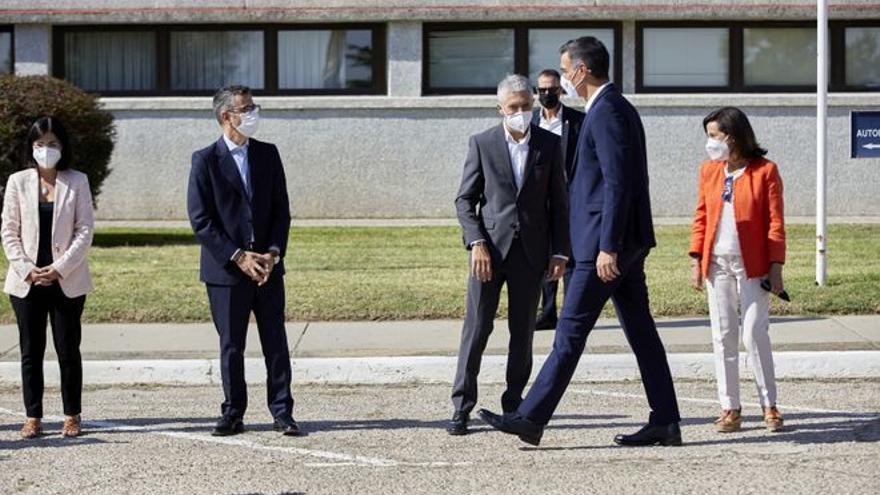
[532,69,584,330]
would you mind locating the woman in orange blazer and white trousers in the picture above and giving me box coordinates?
[689,107,785,432]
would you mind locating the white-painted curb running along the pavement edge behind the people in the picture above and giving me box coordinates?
[0,351,880,386]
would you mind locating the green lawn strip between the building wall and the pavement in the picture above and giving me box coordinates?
[0,225,880,323]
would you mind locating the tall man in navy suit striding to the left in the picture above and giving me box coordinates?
[480,37,681,445]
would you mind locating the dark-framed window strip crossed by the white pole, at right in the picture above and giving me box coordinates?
[636,21,880,93]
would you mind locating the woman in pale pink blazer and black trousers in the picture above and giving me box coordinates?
[0,117,94,438]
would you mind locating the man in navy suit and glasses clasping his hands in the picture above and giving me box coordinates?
[187,86,299,436]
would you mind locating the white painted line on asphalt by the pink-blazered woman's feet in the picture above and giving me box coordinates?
[0,407,471,467]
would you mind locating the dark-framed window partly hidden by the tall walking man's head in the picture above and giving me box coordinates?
[422,22,622,95]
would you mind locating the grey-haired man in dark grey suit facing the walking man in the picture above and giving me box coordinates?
[447,71,569,435]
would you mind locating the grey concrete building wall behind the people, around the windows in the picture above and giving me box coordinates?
[0,0,880,219]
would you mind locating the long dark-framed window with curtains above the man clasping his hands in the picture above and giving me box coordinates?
[53,24,387,96]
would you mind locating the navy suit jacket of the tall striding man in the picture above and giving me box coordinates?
[569,84,656,262]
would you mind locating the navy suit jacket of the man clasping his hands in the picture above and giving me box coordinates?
[187,137,290,285]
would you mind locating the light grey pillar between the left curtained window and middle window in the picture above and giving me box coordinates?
[388,22,422,97]
